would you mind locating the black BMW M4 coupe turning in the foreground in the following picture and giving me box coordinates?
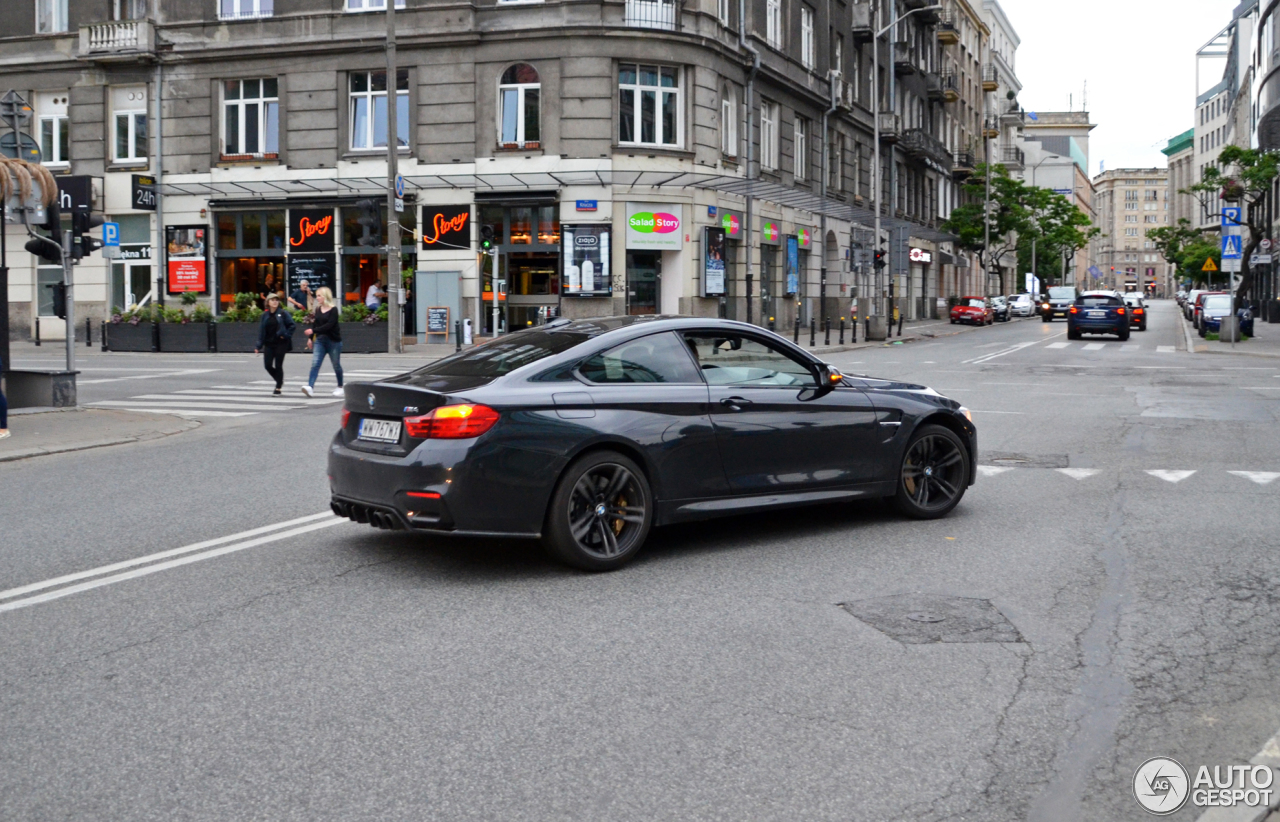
[328,316,978,571]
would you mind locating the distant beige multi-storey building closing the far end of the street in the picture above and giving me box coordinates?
[1091,168,1172,293]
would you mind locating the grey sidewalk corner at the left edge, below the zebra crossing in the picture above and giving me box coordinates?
[0,408,200,462]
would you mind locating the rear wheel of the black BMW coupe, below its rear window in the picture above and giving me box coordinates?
[543,451,653,571]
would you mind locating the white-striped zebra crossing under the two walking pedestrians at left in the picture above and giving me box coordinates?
[87,370,401,419]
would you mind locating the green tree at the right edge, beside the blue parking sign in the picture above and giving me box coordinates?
[1183,146,1280,305]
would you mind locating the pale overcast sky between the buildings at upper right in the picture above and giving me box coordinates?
[998,0,1239,175]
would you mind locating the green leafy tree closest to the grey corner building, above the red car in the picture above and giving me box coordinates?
[942,163,1030,293]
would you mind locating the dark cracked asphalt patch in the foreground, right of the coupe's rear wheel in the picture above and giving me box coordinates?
[840,594,1025,645]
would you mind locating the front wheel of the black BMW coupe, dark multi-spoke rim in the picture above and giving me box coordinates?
[893,425,969,520]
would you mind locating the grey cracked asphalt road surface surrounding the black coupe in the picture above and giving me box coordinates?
[0,303,1280,822]
